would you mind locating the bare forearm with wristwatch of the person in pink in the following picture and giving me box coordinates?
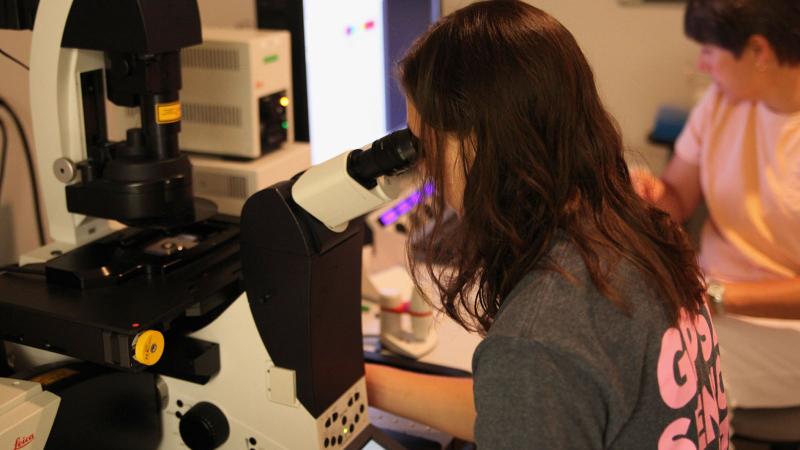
[723,278,800,319]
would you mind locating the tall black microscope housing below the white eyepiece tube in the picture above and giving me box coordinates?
[242,182,364,417]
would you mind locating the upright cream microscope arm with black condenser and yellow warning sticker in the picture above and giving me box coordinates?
[25,0,202,247]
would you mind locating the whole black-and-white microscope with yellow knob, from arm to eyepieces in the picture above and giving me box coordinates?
[0,0,416,450]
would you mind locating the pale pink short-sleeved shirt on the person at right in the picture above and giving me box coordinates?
[675,86,800,281]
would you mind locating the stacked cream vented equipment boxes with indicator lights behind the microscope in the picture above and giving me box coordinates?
[107,28,311,216]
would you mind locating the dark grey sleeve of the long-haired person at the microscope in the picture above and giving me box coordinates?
[473,336,607,450]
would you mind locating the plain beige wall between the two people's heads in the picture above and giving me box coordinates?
[442,0,706,172]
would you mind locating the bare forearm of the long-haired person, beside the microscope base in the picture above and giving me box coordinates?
[365,364,475,441]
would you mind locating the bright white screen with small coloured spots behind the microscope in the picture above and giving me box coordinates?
[303,0,387,164]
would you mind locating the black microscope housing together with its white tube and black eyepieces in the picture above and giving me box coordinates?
[241,130,416,417]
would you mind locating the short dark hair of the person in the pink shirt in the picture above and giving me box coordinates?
[684,0,800,65]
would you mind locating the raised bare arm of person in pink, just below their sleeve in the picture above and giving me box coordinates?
[631,156,703,223]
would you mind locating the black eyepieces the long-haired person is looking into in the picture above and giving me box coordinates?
[347,128,417,189]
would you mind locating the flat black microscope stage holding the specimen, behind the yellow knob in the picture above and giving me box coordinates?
[0,216,243,378]
